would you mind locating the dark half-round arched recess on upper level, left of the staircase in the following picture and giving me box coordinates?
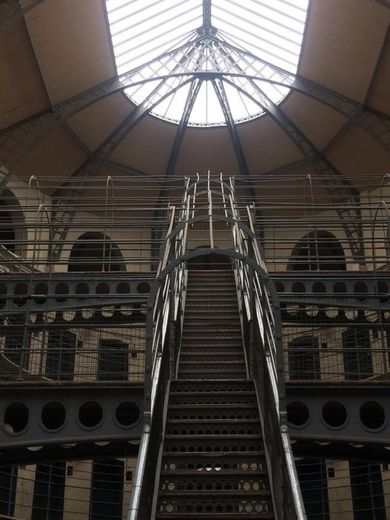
[68,231,126,272]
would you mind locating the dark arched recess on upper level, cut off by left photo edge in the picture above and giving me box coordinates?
[0,188,26,256]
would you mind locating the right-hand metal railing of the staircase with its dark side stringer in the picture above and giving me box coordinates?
[229,180,306,520]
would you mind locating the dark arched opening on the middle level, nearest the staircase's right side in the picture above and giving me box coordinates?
[288,336,321,381]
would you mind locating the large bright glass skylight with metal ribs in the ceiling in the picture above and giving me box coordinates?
[106,0,308,126]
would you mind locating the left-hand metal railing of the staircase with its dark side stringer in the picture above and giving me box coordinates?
[128,179,190,520]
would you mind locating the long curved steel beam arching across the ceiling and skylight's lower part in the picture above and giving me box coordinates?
[0,66,390,193]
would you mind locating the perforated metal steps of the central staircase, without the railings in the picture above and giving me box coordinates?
[156,270,275,520]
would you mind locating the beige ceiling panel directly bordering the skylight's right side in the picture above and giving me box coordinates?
[299,0,390,101]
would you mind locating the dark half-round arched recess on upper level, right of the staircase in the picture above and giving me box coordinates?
[287,231,347,271]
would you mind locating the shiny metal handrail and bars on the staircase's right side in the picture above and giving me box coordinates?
[229,180,307,520]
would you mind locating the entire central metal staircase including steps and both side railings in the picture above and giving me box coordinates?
[128,176,306,520]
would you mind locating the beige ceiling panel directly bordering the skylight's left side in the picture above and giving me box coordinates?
[26,0,115,104]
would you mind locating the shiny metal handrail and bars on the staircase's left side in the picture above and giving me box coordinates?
[127,178,196,520]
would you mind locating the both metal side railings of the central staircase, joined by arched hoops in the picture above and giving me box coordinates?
[128,175,306,520]
